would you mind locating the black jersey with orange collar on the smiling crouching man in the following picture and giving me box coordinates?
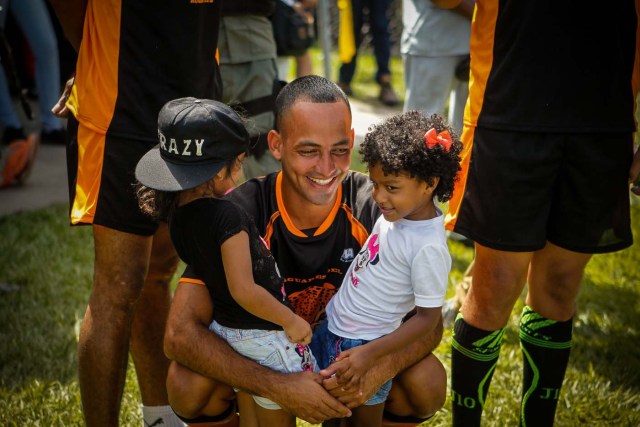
[225,172,380,326]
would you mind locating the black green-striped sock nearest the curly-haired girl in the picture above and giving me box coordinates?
[451,314,504,427]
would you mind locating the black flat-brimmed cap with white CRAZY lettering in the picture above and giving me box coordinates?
[136,98,249,191]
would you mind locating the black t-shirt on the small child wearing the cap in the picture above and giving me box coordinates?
[169,198,288,330]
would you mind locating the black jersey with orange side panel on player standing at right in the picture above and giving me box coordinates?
[463,0,637,134]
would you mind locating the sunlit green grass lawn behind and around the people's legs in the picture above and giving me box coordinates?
[0,45,640,427]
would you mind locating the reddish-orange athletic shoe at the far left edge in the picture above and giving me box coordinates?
[0,133,40,188]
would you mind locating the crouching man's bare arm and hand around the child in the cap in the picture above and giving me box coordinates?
[164,283,351,423]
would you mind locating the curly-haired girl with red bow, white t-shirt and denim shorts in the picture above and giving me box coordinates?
[311,111,462,426]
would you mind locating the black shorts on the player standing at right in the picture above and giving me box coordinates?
[450,128,633,253]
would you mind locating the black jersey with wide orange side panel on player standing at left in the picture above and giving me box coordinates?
[67,0,221,143]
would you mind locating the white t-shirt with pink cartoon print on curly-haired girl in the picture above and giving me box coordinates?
[327,210,451,340]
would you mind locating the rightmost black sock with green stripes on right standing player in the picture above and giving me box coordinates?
[520,306,573,427]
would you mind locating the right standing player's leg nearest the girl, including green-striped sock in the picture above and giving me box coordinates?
[451,244,533,426]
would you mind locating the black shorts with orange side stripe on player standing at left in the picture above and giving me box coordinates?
[67,116,158,236]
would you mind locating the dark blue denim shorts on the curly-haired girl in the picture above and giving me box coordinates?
[309,320,393,406]
